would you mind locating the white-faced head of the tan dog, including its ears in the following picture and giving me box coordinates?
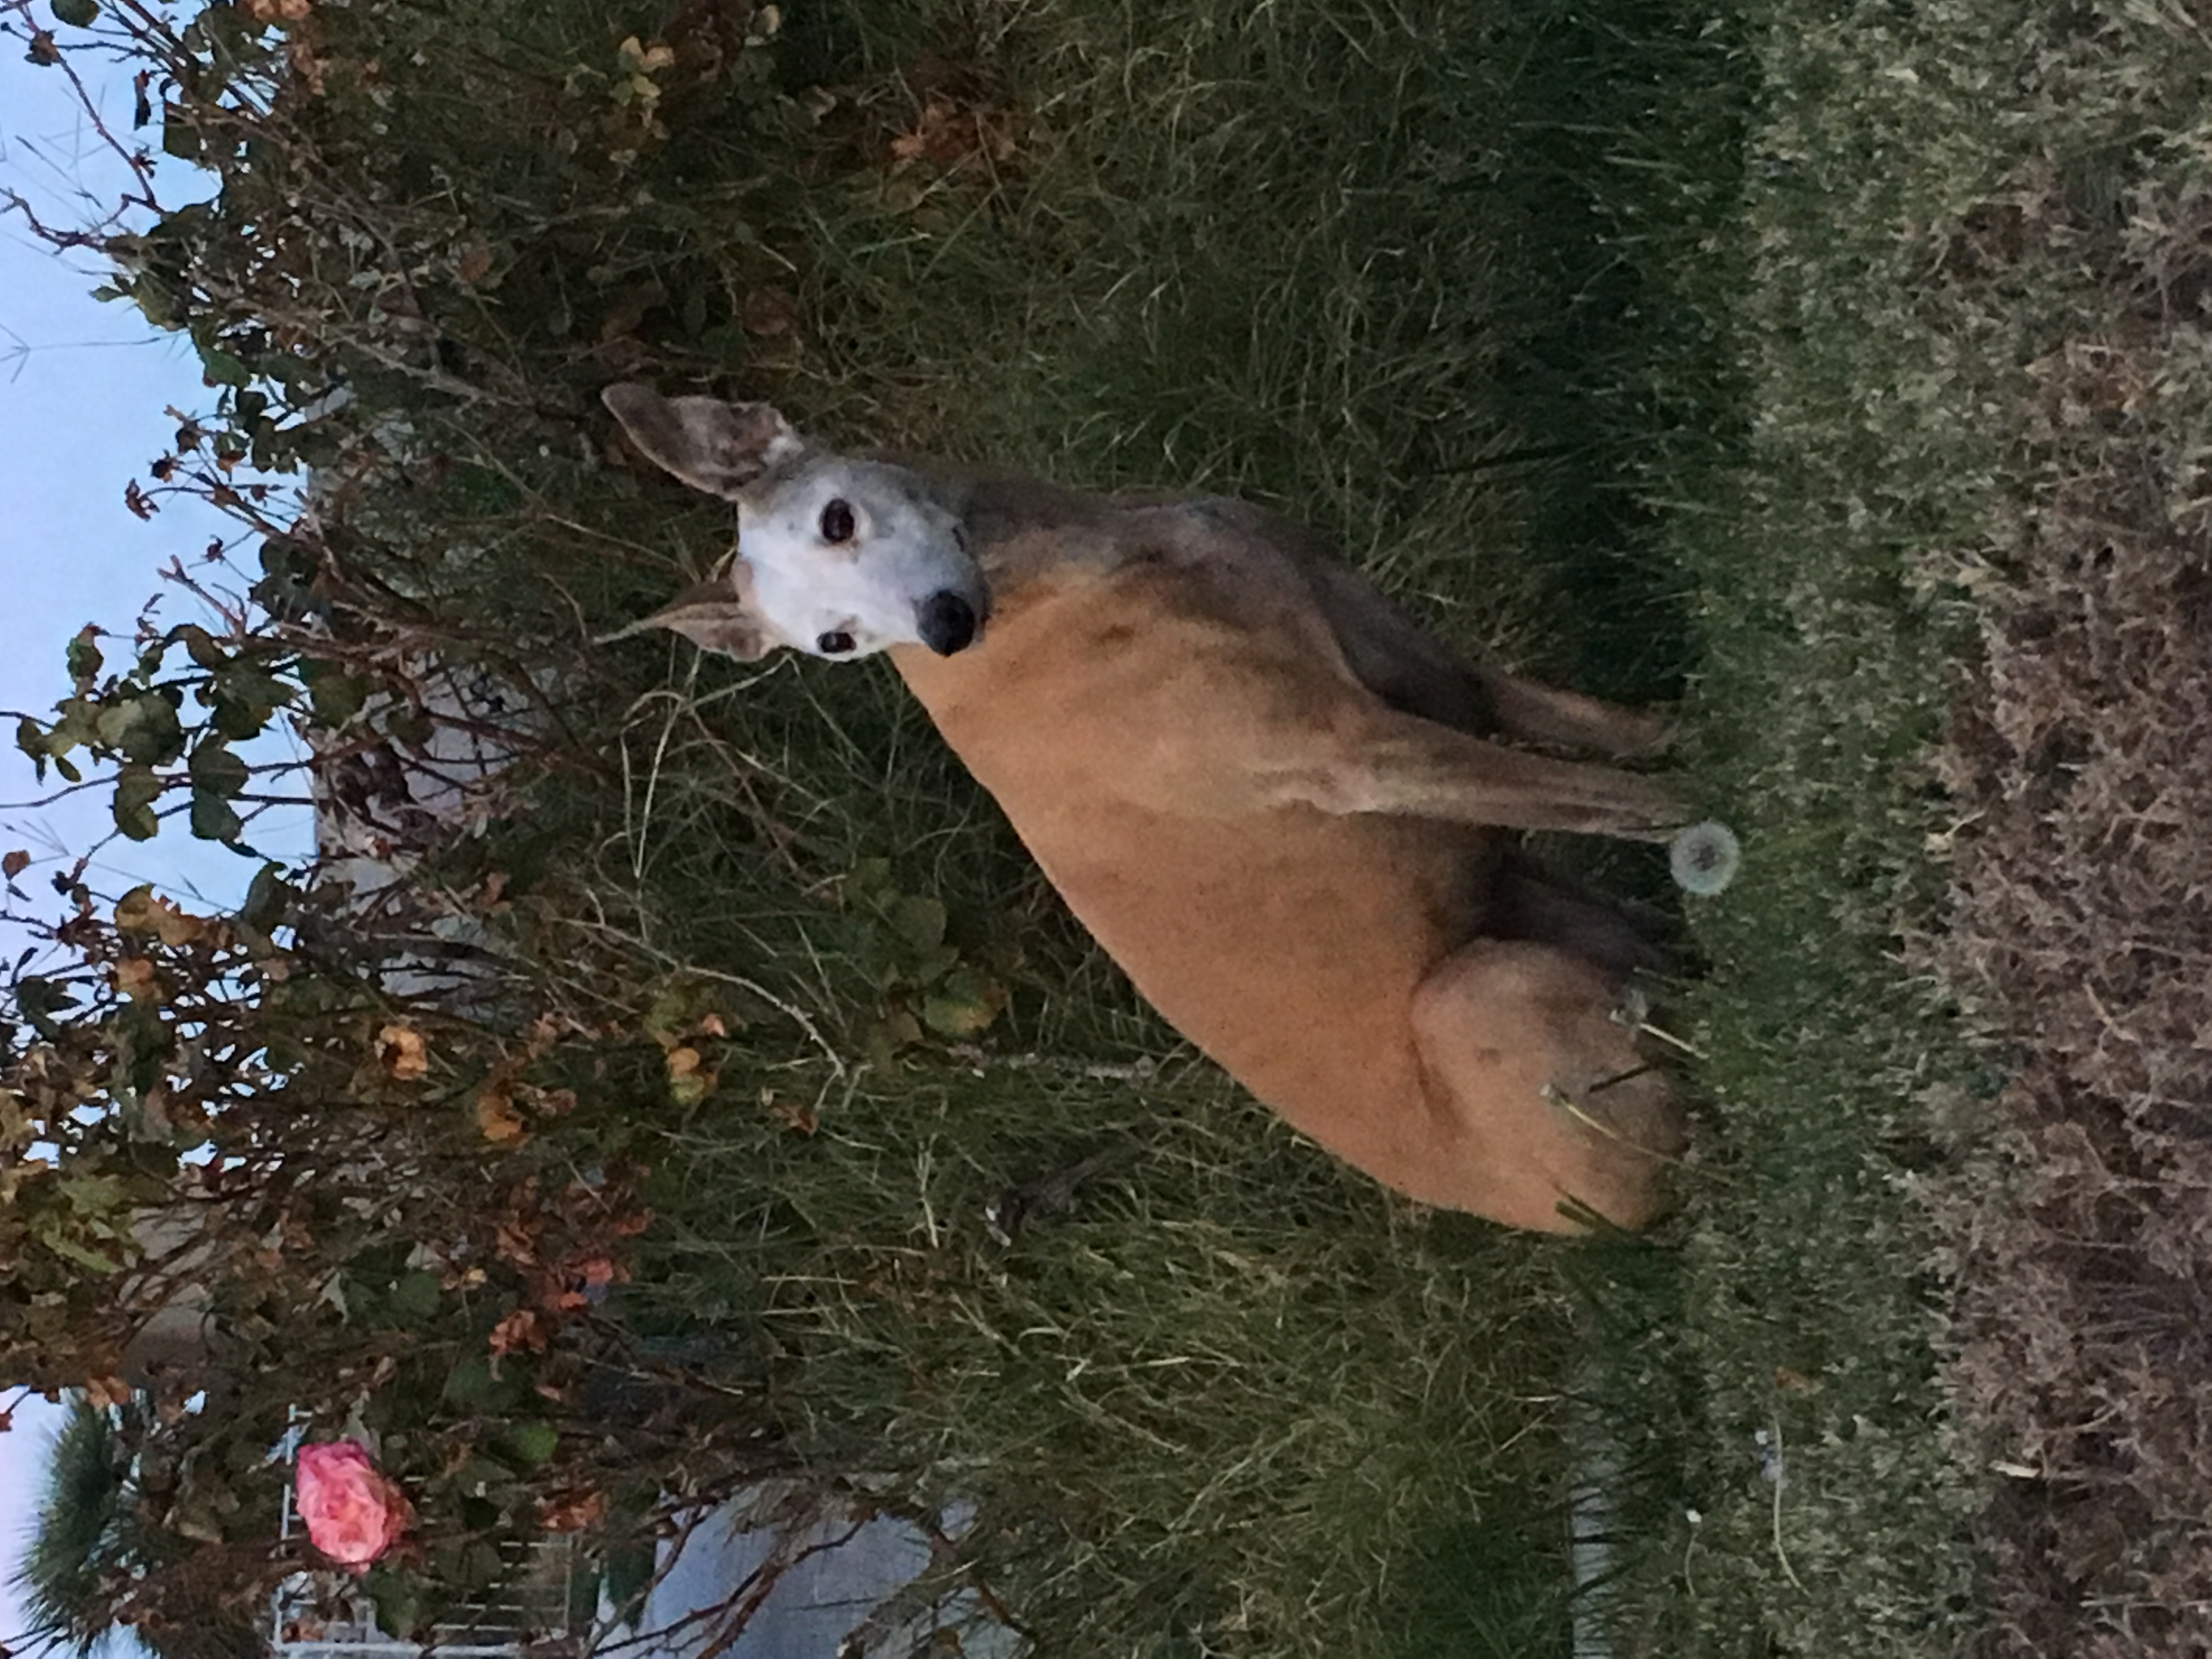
[602,385,991,659]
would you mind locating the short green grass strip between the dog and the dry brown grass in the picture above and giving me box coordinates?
[1566,7,2011,1655]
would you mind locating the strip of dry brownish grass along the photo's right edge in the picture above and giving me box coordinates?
[1942,169,2212,1659]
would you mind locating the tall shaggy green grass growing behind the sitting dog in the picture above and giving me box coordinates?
[320,0,1734,1657]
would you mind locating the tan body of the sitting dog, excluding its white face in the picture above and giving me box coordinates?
[611,382,1681,1230]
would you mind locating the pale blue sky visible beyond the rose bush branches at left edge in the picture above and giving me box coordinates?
[0,40,303,1659]
